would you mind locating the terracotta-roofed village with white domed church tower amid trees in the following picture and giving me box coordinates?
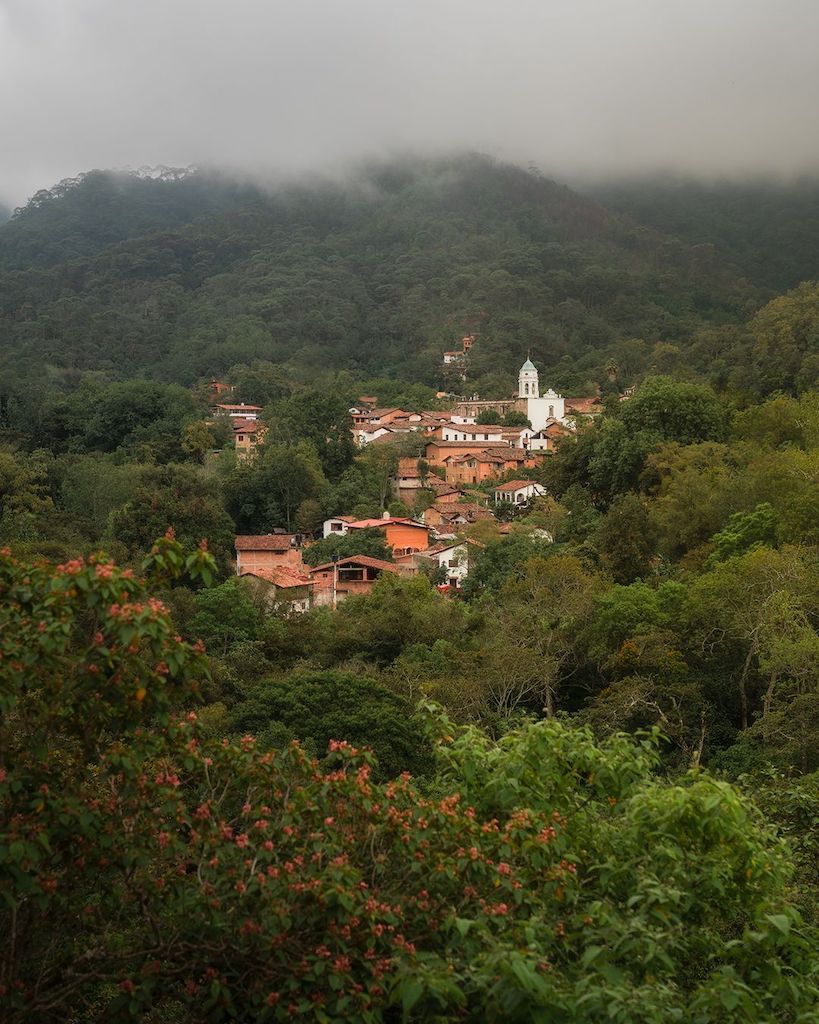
[209,354,603,612]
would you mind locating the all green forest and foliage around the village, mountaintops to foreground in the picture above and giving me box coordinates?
[0,157,819,1024]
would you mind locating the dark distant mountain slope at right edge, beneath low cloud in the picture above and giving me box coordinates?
[590,178,819,292]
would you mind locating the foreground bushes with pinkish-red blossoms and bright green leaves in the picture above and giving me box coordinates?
[0,556,818,1022]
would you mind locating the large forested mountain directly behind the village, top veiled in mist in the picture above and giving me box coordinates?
[0,157,765,407]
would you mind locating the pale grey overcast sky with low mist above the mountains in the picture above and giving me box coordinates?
[0,0,819,204]
